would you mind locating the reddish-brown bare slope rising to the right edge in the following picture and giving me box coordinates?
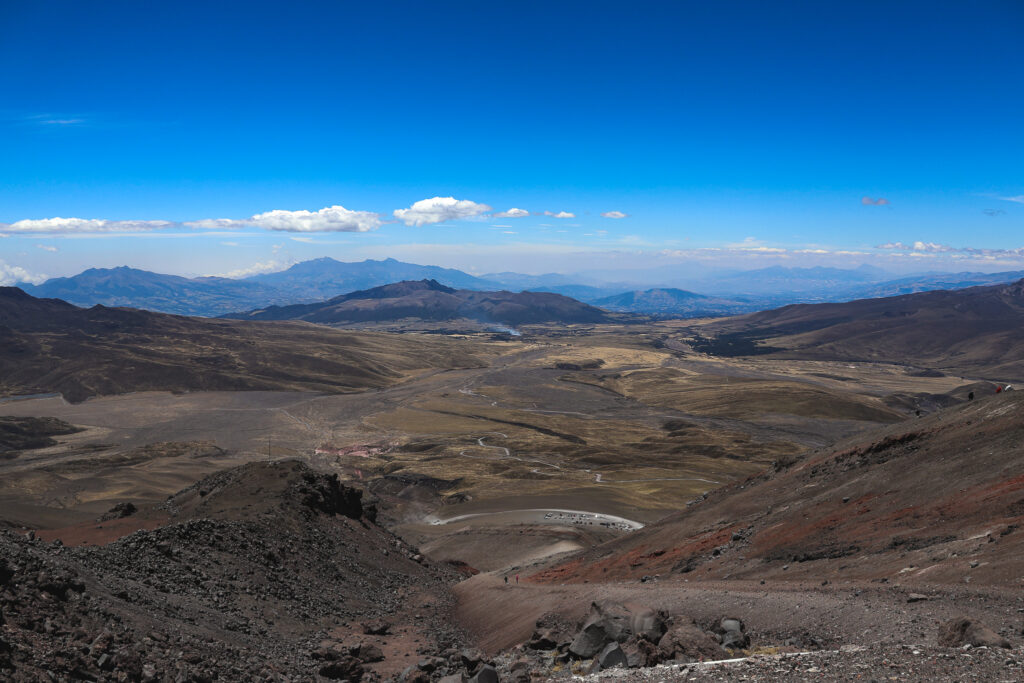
[536,391,1024,588]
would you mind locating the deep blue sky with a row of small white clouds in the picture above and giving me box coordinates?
[0,0,1024,283]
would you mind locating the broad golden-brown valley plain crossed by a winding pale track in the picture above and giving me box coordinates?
[0,322,968,528]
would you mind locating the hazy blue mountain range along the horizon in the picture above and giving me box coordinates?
[18,258,1024,317]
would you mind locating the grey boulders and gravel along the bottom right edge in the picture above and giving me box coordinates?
[483,602,1024,683]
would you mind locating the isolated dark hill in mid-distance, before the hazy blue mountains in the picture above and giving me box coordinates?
[225,280,611,326]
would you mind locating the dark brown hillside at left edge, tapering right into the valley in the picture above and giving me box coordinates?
[0,287,494,401]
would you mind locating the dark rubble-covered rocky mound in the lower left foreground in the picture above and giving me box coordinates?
[0,461,468,681]
